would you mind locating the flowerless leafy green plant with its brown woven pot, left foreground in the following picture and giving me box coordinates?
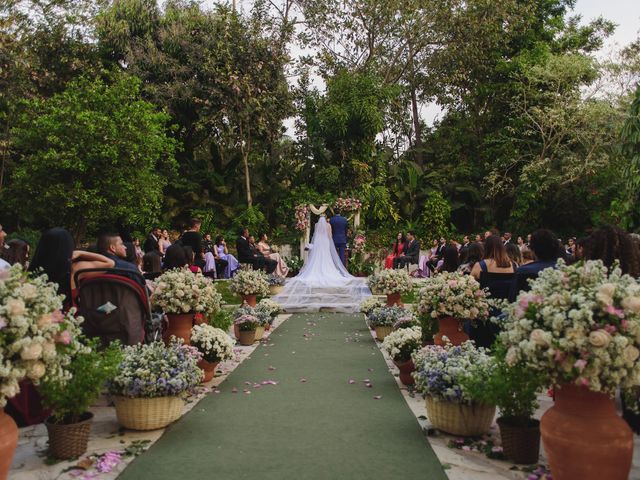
[39,339,122,460]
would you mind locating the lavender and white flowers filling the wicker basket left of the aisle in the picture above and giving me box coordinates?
[108,339,203,398]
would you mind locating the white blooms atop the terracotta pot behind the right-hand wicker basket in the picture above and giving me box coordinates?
[418,272,490,323]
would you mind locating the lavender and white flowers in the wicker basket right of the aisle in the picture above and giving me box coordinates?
[411,342,494,405]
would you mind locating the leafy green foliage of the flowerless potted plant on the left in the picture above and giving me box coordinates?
[38,339,122,423]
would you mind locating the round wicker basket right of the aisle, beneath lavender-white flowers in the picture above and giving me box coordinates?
[426,397,496,437]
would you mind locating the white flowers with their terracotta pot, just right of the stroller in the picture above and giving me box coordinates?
[151,269,222,345]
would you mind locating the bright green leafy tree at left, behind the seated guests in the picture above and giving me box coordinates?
[8,75,175,239]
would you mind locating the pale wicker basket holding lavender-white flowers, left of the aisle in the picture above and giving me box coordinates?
[114,396,184,430]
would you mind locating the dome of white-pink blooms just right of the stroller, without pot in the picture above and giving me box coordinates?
[151,269,222,318]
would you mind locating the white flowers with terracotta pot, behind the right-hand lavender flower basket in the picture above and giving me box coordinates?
[418,272,489,346]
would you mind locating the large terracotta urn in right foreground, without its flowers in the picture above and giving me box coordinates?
[540,384,633,480]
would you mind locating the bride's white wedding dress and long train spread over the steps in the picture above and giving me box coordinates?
[273,216,371,313]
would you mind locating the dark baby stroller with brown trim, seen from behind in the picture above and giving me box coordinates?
[75,268,162,347]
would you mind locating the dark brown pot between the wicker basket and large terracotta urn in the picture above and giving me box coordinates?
[497,417,540,465]
